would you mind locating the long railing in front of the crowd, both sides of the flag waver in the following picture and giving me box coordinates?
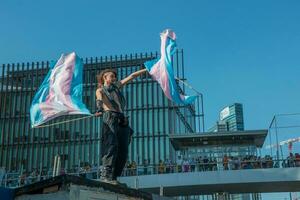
[0,159,300,188]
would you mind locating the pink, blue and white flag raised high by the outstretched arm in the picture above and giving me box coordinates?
[144,29,197,104]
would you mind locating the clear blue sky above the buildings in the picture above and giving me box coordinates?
[0,0,300,198]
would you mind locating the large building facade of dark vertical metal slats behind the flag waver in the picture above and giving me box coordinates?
[0,50,204,171]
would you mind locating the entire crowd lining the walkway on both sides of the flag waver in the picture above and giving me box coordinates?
[0,153,300,187]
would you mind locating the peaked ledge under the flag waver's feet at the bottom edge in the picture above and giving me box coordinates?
[9,175,169,200]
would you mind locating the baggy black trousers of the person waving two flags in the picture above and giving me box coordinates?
[101,112,133,179]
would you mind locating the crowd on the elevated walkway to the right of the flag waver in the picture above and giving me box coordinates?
[123,153,300,176]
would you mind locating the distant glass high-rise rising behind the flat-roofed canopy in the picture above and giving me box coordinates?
[208,103,244,132]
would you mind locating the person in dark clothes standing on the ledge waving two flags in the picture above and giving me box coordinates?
[95,69,147,184]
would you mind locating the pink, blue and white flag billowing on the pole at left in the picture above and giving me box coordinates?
[30,52,91,127]
